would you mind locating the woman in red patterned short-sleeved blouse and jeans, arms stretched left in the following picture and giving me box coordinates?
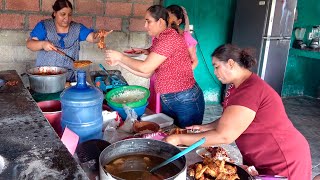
[106,5,204,128]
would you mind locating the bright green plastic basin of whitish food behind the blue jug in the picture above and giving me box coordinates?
[105,86,150,108]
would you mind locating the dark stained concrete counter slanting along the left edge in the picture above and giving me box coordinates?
[0,70,88,179]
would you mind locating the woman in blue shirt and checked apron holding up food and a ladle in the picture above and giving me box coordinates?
[27,0,113,81]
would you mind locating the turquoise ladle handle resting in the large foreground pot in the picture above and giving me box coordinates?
[150,137,206,173]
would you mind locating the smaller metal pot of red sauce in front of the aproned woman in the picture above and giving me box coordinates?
[27,66,67,93]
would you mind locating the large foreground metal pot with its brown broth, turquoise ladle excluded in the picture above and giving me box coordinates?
[99,138,187,180]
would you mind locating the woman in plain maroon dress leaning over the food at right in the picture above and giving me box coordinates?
[165,45,311,180]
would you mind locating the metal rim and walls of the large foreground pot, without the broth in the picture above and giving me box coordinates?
[99,138,187,180]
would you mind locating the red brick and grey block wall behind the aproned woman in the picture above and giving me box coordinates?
[0,0,160,87]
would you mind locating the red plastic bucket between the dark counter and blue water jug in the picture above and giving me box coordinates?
[37,100,62,137]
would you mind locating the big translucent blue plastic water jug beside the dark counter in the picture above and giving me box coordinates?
[60,70,103,143]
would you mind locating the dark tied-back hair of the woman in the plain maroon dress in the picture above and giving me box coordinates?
[211,44,256,69]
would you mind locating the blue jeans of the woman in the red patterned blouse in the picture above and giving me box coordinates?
[160,83,205,128]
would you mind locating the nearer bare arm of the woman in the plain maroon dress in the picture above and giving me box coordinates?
[165,105,256,146]
